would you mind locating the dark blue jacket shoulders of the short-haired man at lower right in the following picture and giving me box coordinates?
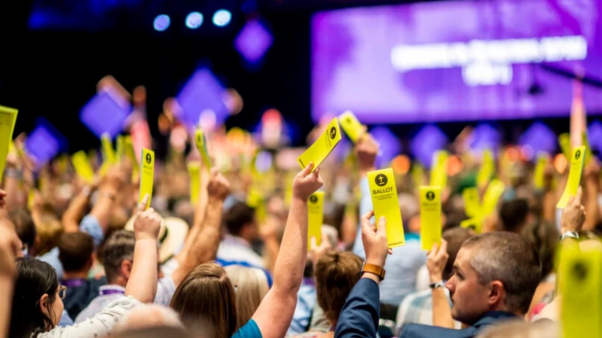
[399,311,518,338]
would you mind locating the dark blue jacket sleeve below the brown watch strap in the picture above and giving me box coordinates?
[334,278,380,338]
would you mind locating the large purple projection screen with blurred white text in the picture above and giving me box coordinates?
[311,0,602,123]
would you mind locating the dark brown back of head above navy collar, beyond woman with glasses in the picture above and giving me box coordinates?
[58,232,94,272]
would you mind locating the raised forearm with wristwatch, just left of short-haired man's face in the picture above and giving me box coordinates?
[426,239,455,329]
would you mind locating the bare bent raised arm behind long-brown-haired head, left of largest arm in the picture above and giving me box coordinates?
[171,169,230,287]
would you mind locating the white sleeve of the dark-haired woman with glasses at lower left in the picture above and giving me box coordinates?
[37,297,144,338]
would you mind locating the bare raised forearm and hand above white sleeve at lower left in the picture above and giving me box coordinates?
[125,195,161,303]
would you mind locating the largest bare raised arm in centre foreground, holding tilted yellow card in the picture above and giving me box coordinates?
[253,163,323,338]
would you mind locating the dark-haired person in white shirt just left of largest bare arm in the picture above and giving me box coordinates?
[217,202,265,268]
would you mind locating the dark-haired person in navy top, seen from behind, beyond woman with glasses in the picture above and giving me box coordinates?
[58,232,107,318]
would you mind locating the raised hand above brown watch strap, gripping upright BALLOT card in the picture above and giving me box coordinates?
[361,211,391,267]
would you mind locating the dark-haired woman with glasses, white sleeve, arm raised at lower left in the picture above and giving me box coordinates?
[9,203,160,338]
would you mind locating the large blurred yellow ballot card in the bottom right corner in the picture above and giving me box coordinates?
[558,243,602,338]
